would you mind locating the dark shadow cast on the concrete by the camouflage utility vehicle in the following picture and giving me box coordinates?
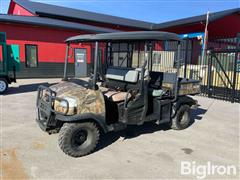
[96,108,207,151]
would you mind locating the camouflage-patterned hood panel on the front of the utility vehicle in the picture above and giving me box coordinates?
[50,82,106,117]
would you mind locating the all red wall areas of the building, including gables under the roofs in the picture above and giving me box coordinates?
[4,1,240,79]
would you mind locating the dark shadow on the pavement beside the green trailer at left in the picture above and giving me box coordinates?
[4,82,56,96]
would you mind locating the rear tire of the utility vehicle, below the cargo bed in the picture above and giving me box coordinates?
[171,104,191,130]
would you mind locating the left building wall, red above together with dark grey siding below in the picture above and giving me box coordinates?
[0,23,97,78]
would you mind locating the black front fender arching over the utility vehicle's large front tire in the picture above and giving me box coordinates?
[56,113,109,133]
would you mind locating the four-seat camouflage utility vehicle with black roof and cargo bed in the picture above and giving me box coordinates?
[37,31,200,157]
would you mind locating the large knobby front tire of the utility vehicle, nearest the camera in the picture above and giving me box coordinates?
[58,122,100,157]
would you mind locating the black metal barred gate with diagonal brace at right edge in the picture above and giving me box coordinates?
[202,49,240,102]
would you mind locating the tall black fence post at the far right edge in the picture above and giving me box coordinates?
[231,34,240,103]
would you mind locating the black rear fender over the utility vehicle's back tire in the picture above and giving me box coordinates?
[172,96,198,117]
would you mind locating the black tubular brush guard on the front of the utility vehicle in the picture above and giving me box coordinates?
[36,86,69,132]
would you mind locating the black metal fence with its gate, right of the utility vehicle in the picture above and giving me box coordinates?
[180,36,240,102]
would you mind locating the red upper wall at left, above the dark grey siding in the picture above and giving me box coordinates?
[0,24,91,63]
